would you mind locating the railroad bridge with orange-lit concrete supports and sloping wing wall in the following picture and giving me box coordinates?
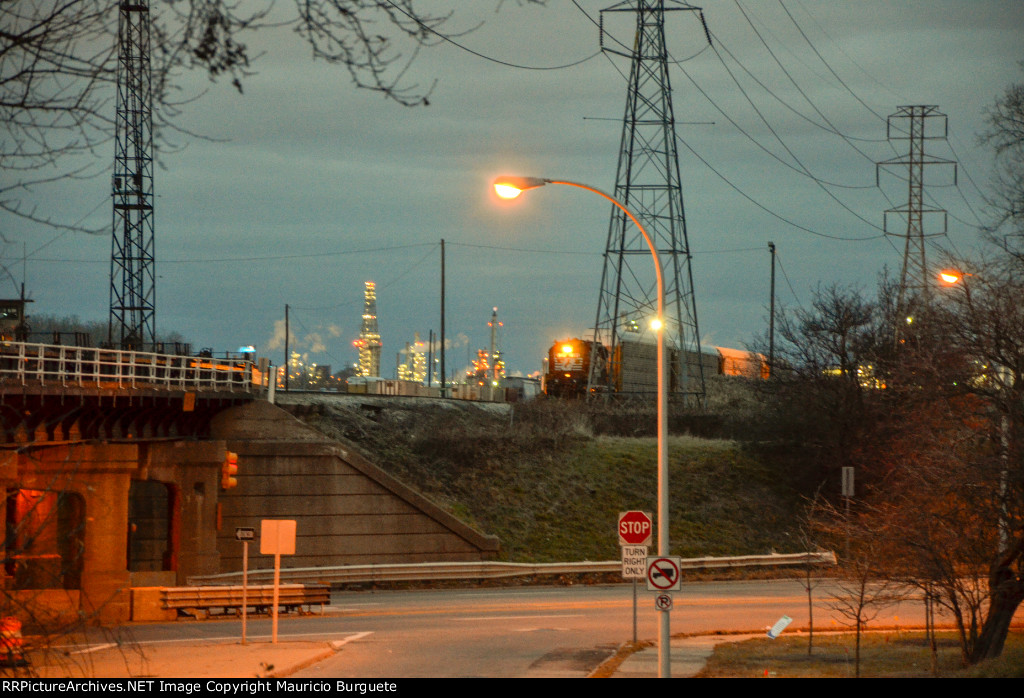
[0,342,498,622]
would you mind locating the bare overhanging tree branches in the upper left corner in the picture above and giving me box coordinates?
[0,0,543,229]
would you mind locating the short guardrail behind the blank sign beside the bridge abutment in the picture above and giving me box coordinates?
[161,584,331,617]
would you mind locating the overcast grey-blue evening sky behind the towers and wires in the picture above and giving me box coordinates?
[6,0,1024,377]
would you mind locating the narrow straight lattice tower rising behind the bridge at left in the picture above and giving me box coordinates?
[108,0,157,348]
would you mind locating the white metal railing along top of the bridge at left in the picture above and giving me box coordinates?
[0,342,265,392]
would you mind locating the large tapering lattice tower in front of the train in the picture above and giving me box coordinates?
[590,0,705,402]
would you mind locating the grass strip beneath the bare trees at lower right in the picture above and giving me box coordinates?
[697,631,1024,679]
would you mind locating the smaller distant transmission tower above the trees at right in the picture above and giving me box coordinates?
[874,105,956,317]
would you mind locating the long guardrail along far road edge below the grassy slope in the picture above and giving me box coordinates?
[188,551,836,584]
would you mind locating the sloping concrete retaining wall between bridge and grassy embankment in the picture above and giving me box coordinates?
[212,402,499,572]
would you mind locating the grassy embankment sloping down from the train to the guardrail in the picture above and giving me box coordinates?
[284,401,801,562]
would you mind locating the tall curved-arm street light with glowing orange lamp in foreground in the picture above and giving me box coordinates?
[494,176,670,678]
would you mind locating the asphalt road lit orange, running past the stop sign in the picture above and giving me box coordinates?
[95,581,974,679]
